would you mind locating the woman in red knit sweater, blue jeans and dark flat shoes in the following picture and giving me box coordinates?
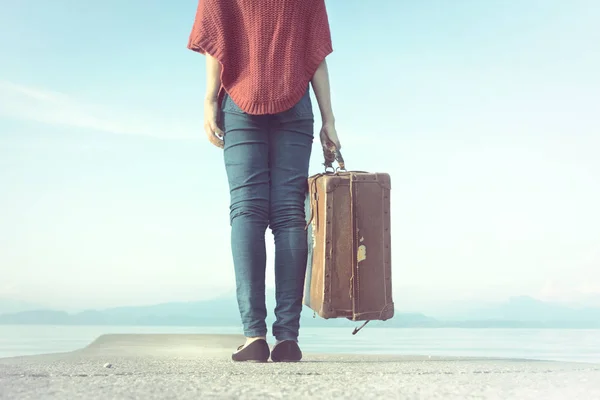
[188,0,341,362]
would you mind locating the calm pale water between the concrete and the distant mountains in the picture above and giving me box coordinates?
[0,325,600,363]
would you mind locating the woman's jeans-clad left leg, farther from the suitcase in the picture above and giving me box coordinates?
[223,97,270,338]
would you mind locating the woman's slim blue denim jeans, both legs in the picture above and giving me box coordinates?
[221,90,314,340]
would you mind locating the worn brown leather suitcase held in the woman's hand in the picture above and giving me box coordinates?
[303,148,394,333]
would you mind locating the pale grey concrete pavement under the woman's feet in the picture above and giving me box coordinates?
[0,335,600,400]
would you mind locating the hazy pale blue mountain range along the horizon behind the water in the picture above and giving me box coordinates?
[0,296,600,329]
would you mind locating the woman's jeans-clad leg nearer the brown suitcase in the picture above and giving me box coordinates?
[269,92,314,341]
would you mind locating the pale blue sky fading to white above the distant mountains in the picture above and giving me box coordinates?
[0,0,600,312]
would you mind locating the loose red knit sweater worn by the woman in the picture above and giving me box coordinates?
[188,0,333,114]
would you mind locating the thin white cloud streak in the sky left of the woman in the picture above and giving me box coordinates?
[0,81,196,139]
